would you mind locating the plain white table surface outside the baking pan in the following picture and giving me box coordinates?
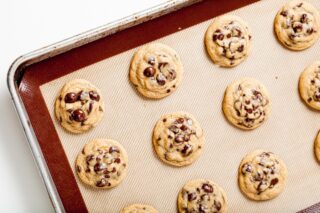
[0,0,165,213]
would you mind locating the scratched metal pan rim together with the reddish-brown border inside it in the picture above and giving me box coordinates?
[7,0,320,212]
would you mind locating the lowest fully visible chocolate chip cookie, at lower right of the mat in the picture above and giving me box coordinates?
[238,150,287,200]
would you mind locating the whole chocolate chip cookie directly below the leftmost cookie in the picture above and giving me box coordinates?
[76,139,128,189]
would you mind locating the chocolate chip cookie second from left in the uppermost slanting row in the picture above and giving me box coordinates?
[129,43,183,99]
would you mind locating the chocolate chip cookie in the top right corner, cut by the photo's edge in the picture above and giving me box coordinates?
[274,0,320,50]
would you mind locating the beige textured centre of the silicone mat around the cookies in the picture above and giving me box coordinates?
[41,0,320,213]
